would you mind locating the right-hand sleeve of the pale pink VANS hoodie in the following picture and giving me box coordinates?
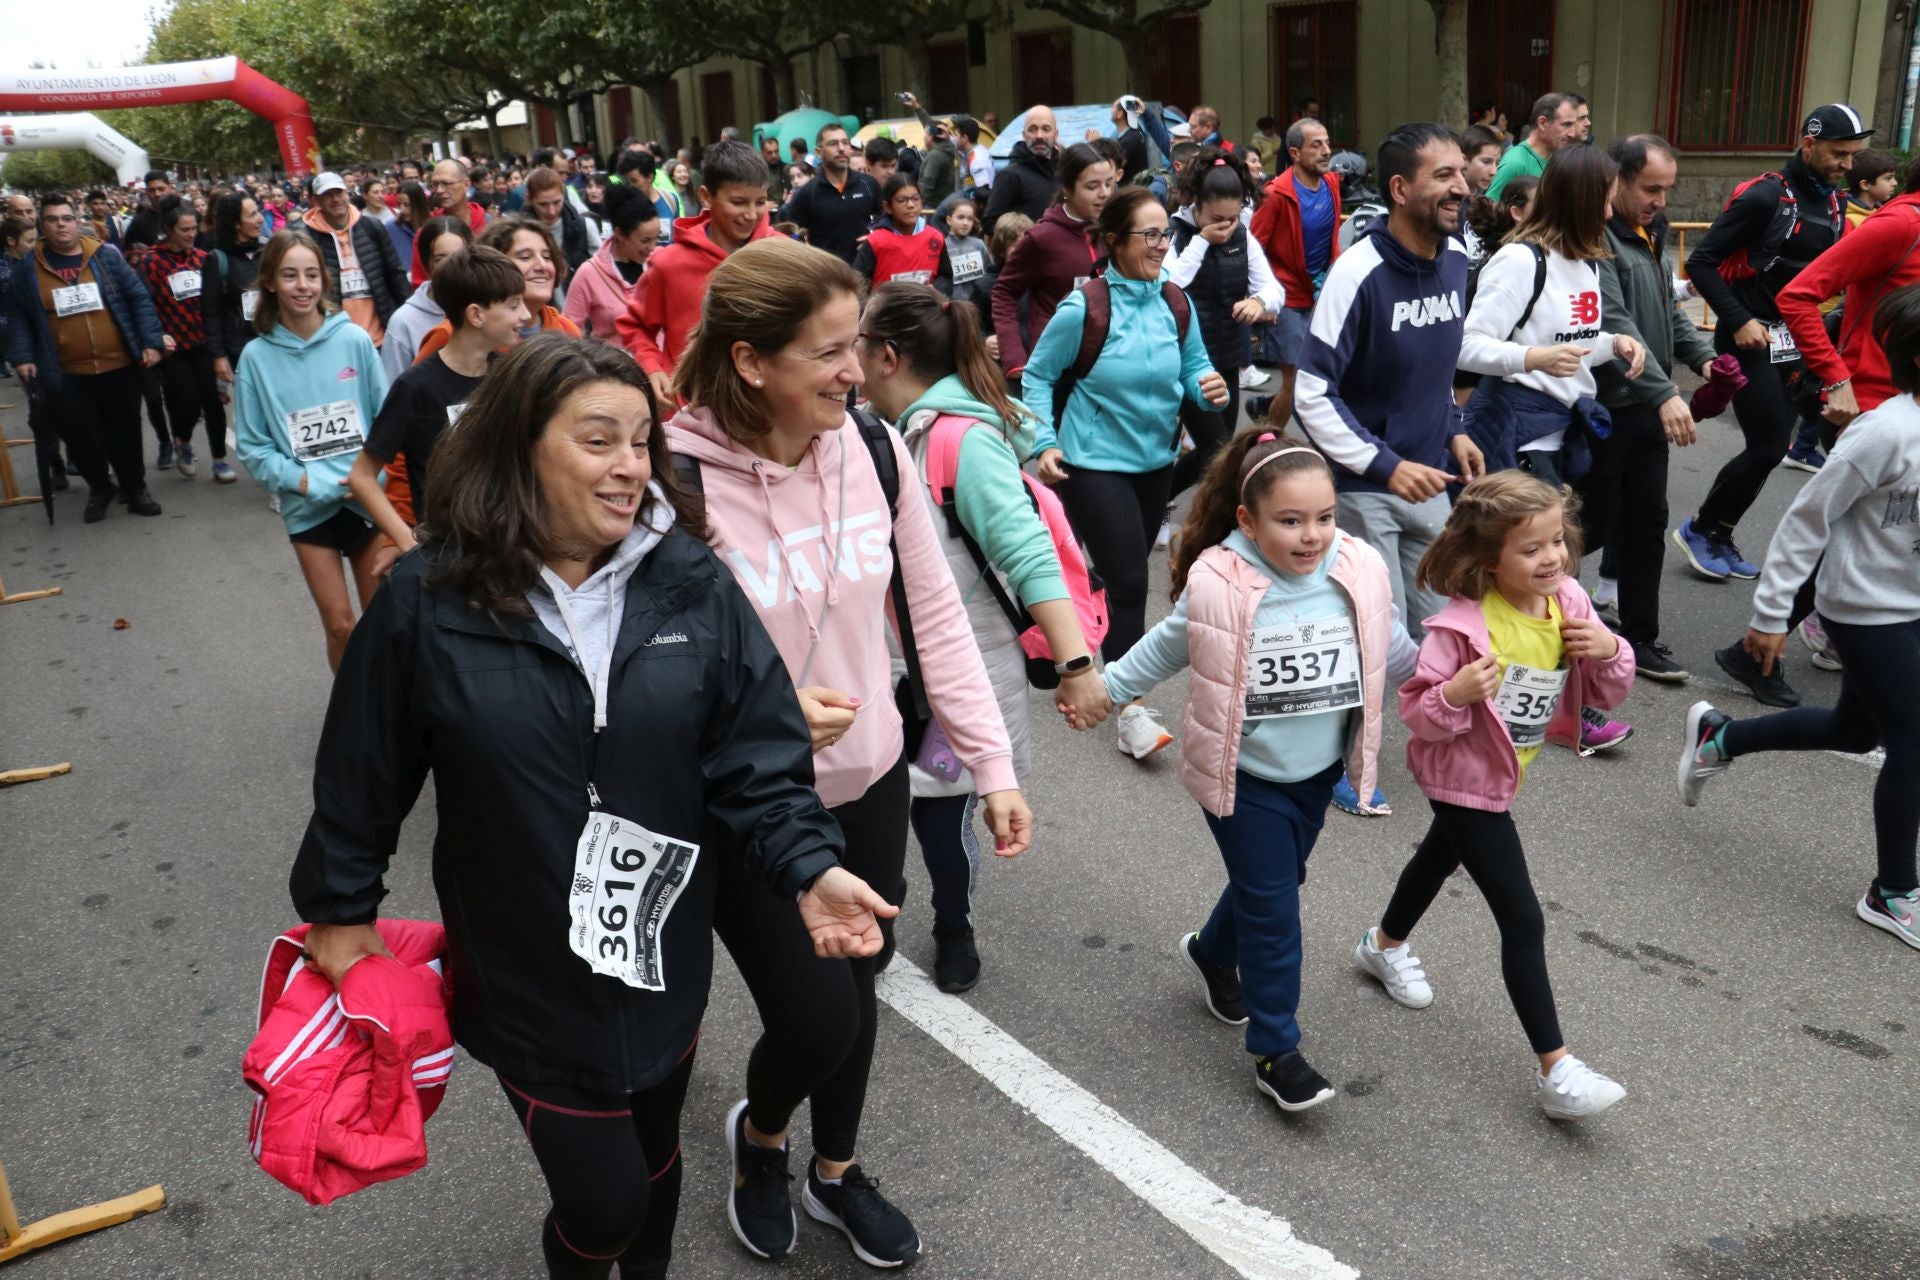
[887,426,1020,796]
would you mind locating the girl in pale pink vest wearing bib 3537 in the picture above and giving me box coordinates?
[1082,432,1411,1111]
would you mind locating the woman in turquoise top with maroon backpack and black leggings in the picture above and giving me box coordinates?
[1000,185,1229,760]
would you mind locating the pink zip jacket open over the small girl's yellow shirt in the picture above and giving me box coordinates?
[1400,578,1634,814]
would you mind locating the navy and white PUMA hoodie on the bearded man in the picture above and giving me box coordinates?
[1294,219,1467,491]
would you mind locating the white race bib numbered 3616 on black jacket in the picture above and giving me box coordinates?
[566,810,701,990]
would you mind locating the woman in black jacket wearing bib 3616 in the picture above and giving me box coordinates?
[292,334,895,1280]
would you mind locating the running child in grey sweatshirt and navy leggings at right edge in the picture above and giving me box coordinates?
[1680,284,1920,948]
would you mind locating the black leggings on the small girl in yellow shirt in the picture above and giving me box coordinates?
[1380,800,1567,1054]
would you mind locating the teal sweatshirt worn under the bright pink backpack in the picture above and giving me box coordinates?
[900,374,1068,608]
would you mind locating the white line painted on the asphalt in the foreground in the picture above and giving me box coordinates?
[879,954,1359,1280]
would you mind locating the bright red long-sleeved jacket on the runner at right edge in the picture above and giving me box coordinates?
[1774,196,1920,413]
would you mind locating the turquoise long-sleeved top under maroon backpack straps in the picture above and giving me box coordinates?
[1021,273,1213,476]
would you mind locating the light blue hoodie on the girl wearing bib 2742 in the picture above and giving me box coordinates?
[234,311,386,533]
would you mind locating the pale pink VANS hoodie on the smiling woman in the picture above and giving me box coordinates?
[666,409,1020,808]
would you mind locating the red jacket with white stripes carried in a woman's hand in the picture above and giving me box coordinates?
[242,919,453,1205]
